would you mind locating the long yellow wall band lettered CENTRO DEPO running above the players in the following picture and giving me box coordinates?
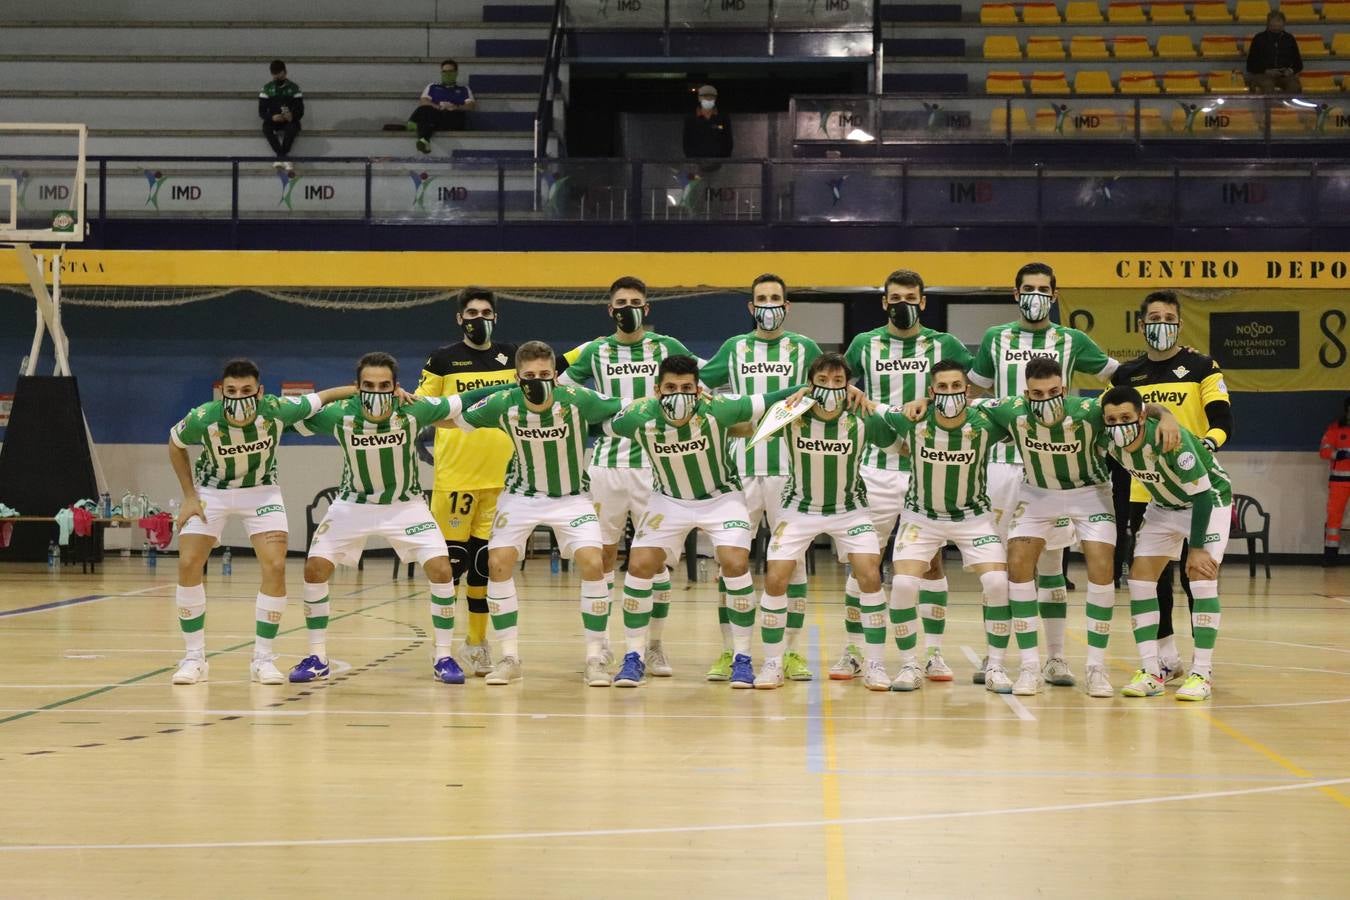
[0,250,1350,296]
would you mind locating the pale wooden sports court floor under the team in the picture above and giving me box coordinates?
[0,559,1350,897]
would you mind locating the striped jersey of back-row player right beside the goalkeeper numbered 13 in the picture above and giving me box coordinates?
[558,332,693,468]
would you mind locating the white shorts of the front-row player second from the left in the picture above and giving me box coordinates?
[309,499,448,565]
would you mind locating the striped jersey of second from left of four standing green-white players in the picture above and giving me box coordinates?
[699,332,821,476]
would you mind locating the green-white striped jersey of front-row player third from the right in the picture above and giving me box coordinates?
[884,405,1010,522]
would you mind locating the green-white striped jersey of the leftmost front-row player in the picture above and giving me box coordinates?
[169,394,320,490]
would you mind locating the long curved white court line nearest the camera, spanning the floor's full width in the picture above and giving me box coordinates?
[0,779,1350,853]
